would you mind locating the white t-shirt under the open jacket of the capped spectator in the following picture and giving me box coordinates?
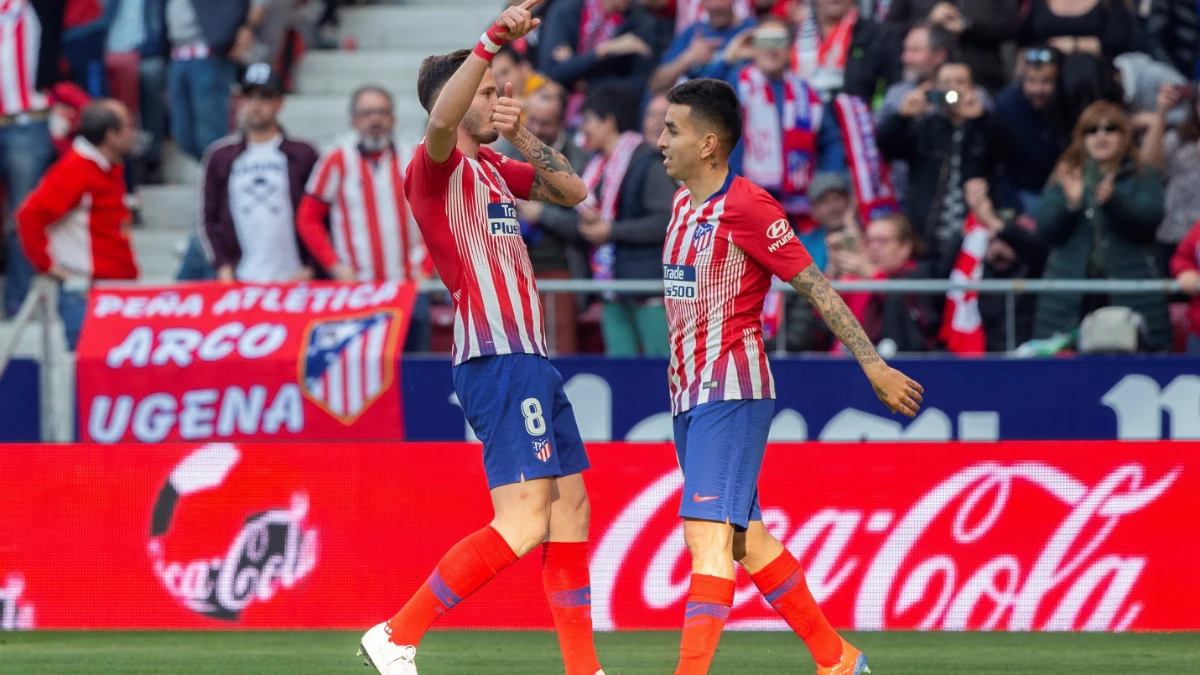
[229,136,304,283]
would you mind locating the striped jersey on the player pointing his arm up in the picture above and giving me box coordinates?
[404,142,547,365]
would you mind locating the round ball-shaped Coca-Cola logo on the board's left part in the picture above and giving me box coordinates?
[148,443,317,621]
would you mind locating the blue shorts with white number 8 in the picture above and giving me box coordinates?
[454,354,590,489]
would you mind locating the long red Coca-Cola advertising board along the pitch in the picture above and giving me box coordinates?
[0,442,1200,631]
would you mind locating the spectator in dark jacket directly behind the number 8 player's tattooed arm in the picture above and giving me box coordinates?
[494,88,592,354]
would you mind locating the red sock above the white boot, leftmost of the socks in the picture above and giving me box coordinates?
[388,526,517,646]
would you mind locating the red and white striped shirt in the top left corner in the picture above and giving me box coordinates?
[0,0,48,115]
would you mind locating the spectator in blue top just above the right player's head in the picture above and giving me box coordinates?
[650,0,756,94]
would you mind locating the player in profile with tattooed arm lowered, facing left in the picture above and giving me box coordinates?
[658,79,923,675]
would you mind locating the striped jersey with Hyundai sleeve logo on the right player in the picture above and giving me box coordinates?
[662,173,812,414]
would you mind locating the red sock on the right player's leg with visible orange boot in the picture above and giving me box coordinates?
[750,550,841,667]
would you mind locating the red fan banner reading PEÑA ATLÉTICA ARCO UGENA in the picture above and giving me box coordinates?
[77,283,416,443]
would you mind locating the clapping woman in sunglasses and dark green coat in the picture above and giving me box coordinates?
[1033,101,1171,351]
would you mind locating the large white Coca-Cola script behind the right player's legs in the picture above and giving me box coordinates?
[592,461,1182,631]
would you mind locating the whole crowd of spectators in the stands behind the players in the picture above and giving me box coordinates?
[7,0,1200,356]
